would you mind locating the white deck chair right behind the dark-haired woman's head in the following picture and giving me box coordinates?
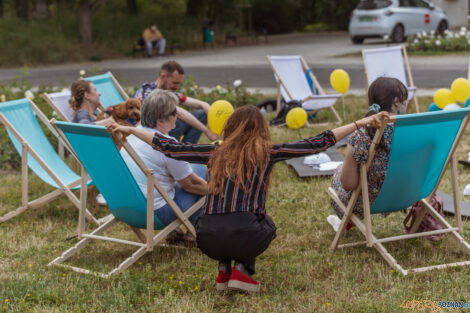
[362,45,419,112]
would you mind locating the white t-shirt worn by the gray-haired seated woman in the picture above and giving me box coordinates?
[121,125,193,210]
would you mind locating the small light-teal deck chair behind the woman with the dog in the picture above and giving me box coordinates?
[85,72,129,110]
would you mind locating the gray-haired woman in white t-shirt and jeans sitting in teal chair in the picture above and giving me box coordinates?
[116,90,208,241]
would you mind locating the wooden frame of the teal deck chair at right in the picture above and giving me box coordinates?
[328,114,470,275]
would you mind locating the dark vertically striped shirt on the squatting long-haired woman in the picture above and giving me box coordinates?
[153,130,336,214]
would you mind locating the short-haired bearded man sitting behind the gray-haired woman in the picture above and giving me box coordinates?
[134,61,218,143]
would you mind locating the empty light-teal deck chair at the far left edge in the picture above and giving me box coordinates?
[0,98,99,224]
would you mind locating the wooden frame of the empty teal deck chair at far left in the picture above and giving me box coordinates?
[0,100,100,225]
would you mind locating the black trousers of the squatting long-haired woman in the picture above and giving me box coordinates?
[196,212,276,275]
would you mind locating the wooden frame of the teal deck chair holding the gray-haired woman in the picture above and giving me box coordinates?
[48,125,205,278]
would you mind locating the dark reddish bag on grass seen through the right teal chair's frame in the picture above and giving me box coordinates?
[403,195,446,241]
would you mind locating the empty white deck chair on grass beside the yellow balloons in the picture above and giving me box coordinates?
[267,55,342,123]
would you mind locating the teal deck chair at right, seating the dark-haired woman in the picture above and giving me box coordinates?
[328,109,470,275]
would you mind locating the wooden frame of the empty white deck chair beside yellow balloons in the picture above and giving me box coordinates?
[266,55,343,126]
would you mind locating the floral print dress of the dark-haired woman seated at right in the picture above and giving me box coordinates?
[331,125,393,219]
